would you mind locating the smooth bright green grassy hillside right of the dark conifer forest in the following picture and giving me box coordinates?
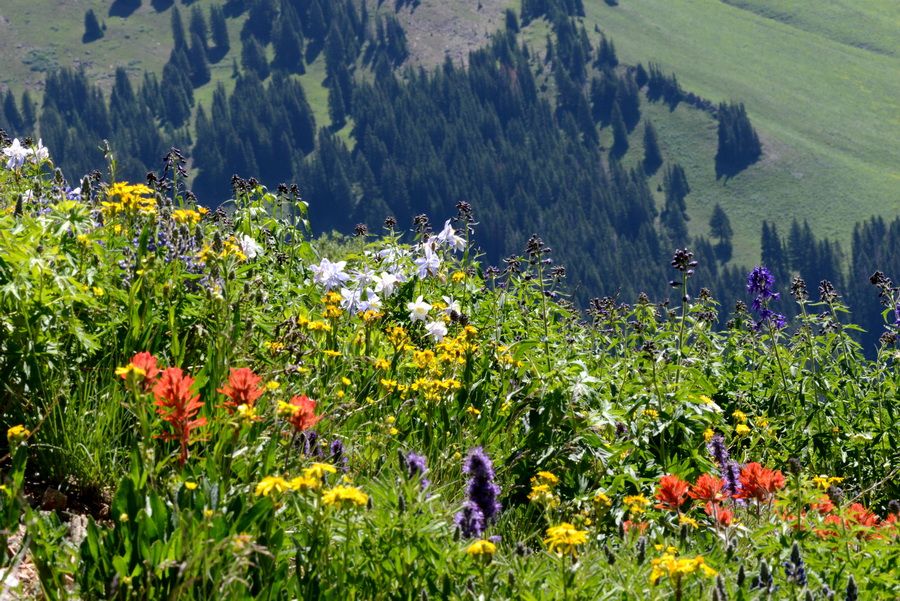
[585,0,900,258]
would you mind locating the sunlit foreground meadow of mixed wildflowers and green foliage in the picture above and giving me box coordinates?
[0,140,900,601]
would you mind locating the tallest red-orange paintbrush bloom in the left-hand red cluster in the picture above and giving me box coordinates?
[153,367,206,465]
